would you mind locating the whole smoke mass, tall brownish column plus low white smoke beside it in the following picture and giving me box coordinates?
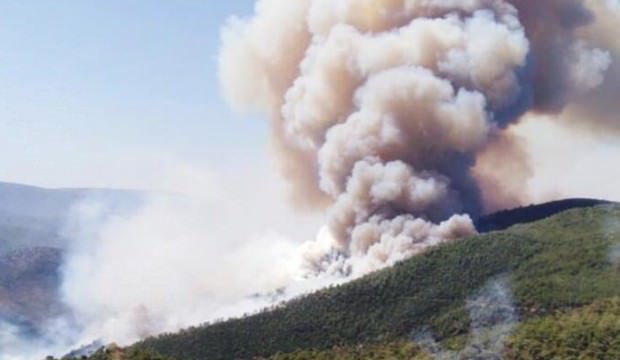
[6,0,620,358]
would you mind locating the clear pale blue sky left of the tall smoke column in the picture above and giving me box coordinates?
[0,0,262,189]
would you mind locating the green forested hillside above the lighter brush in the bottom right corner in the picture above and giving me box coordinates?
[124,205,620,360]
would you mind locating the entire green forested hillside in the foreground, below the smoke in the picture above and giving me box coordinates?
[128,201,620,360]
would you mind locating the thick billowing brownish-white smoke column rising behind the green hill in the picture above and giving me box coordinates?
[220,0,616,274]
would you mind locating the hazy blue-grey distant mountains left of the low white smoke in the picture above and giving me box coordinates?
[0,182,146,337]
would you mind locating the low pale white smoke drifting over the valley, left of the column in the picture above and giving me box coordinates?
[54,165,332,344]
